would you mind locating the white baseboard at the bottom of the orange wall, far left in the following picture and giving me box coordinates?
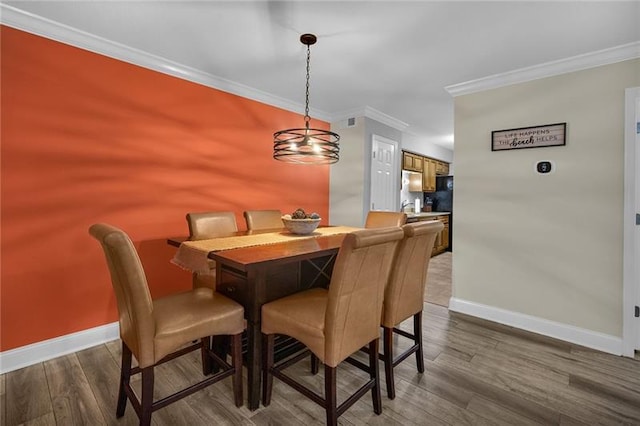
[0,322,120,374]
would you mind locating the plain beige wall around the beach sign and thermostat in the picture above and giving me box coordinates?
[452,60,640,338]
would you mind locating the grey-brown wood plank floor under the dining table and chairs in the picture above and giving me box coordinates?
[5,303,640,426]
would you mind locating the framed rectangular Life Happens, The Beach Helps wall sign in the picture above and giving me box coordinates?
[491,123,567,151]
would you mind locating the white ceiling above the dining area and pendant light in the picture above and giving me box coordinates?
[2,1,640,149]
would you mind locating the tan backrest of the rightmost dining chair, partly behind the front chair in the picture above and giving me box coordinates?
[382,221,444,328]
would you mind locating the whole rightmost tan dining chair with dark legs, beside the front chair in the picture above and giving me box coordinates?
[381,221,444,399]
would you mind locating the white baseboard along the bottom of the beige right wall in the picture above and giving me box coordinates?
[449,297,622,355]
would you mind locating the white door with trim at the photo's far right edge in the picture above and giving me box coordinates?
[622,87,640,357]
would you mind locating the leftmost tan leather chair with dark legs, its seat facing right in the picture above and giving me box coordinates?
[89,223,244,426]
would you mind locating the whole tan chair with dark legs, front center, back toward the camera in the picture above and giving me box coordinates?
[262,228,404,425]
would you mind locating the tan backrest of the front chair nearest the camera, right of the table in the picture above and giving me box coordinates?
[324,228,404,367]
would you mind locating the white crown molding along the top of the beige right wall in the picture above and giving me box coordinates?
[445,41,640,97]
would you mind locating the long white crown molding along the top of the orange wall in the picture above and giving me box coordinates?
[0,3,331,122]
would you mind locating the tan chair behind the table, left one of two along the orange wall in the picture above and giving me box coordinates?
[186,211,238,290]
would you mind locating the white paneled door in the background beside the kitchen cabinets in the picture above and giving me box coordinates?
[370,135,400,211]
